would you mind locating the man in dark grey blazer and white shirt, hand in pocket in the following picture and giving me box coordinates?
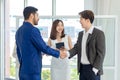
[69,10,105,80]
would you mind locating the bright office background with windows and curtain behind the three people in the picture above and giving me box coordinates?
[0,0,120,80]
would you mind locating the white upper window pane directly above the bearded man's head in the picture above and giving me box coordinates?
[27,0,52,15]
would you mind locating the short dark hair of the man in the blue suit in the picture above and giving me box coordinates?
[23,6,38,20]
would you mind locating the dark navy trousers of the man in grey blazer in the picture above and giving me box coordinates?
[79,64,100,80]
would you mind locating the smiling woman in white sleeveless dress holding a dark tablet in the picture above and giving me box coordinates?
[48,19,72,80]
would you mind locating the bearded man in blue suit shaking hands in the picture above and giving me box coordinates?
[15,6,67,80]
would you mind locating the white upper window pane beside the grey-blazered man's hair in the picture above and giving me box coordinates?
[56,0,84,15]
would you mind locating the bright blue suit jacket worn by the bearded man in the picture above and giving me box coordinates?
[15,22,59,74]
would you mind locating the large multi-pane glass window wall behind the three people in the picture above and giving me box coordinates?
[0,0,116,80]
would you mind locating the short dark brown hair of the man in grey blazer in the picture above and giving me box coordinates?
[79,10,94,23]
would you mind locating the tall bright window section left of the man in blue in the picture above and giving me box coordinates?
[5,0,24,79]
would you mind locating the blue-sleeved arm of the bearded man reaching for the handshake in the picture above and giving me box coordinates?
[31,28,60,58]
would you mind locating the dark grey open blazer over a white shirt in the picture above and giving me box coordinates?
[69,28,105,75]
